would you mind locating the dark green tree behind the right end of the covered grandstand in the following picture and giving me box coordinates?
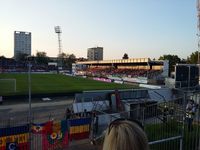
[159,54,181,72]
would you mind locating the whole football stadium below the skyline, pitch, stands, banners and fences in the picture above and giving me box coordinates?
[0,55,200,150]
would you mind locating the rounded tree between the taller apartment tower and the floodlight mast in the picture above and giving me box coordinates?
[35,51,49,65]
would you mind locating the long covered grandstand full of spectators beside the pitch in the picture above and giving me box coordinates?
[72,58,169,83]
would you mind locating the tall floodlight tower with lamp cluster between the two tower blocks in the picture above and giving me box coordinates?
[55,26,62,69]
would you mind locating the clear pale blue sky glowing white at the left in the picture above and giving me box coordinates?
[0,0,197,59]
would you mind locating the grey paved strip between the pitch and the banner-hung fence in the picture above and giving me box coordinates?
[0,98,73,120]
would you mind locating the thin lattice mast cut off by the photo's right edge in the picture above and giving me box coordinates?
[197,0,200,64]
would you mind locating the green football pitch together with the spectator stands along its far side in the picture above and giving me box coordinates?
[0,58,169,96]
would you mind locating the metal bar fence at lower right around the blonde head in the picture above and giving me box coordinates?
[92,96,200,150]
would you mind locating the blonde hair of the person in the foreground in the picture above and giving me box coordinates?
[103,120,149,150]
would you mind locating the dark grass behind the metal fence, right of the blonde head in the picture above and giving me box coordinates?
[145,120,200,150]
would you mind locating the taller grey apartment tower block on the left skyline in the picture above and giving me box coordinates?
[14,31,31,59]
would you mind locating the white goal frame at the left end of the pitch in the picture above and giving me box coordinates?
[0,79,16,93]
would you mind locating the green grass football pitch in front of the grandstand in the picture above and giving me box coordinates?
[0,74,135,96]
